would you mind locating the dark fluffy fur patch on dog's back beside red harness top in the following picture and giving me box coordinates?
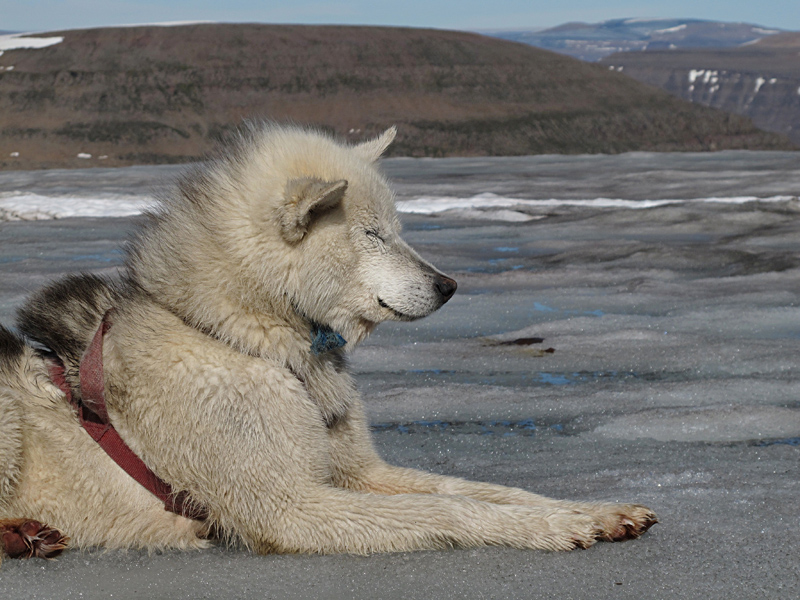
[17,273,115,389]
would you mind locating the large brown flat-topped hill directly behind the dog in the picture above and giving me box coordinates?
[0,24,792,169]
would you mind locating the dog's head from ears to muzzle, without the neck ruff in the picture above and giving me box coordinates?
[239,127,456,342]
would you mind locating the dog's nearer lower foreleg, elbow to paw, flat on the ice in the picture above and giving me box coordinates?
[250,486,600,554]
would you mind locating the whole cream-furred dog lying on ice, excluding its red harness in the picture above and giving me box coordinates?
[0,125,655,554]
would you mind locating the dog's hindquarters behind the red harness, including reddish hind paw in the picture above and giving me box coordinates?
[0,327,209,558]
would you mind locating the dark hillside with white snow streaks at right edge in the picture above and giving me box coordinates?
[602,33,800,145]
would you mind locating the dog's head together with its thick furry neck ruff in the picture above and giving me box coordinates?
[139,124,456,347]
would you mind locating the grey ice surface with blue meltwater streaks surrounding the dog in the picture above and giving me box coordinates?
[0,152,800,599]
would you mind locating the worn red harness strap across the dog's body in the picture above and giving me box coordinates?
[48,313,208,521]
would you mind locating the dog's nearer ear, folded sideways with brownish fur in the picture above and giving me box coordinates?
[280,177,347,243]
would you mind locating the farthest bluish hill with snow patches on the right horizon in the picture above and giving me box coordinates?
[487,19,781,62]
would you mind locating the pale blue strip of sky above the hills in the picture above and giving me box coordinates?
[0,0,800,32]
